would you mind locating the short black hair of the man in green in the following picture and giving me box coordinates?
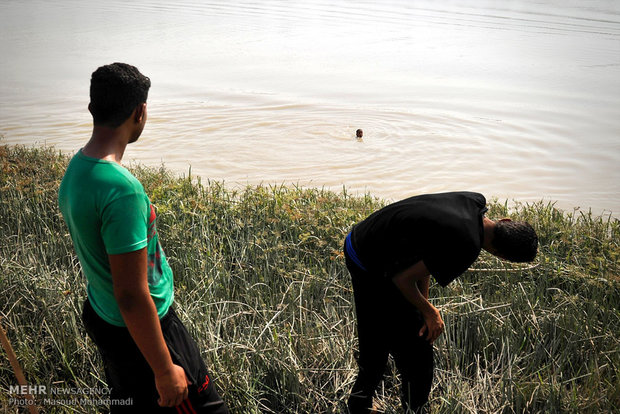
[90,63,151,128]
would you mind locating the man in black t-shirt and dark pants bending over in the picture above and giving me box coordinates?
[344,192,538,414]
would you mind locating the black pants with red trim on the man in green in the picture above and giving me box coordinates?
[82,299,228,414]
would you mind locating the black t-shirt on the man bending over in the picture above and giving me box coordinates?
[351,192,487,286]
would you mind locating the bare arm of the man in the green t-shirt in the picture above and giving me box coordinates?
[108,248,188,407]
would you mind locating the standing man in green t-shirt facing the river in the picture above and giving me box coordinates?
[58,63,228,414]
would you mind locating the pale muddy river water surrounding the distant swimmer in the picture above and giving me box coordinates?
[0,0,620,216]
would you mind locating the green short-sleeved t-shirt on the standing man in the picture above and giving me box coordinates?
[58,150,174,326]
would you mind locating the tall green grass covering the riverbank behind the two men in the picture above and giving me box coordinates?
[0,146,620,414]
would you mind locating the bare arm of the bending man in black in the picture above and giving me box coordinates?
[392,260,444,343]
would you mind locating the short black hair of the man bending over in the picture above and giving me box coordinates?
[492,220,538,262]
